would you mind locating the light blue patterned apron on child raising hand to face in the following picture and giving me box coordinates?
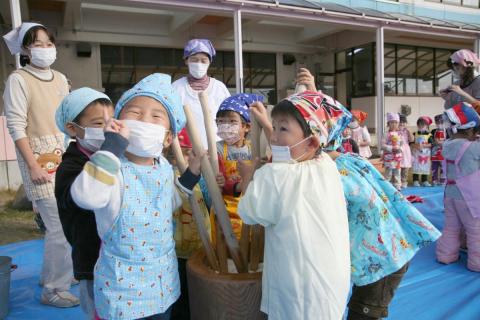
[95,159,180,319]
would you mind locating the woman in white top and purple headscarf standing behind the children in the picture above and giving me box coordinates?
[172,39,230,149]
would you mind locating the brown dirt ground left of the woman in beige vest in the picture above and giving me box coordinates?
[0,191,43,245]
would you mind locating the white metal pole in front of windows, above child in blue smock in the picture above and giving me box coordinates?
[375,27,385,150]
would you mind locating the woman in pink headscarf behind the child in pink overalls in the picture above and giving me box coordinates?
[440,49,480,109]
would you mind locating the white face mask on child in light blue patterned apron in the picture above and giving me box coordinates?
[125,120,167,158]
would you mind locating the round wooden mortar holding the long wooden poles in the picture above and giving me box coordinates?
[187,250,267,320]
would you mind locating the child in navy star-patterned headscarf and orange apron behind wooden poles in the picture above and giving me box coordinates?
[211,93,263,238]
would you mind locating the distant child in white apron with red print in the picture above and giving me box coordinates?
[411,116,433,187]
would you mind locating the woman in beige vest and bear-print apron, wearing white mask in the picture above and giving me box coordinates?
[3,23,79,308]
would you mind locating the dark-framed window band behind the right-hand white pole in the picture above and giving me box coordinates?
[335,43,454,97]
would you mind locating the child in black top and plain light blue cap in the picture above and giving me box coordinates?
[55,88,113,319]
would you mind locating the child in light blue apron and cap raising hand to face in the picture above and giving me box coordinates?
[70,73,203,320]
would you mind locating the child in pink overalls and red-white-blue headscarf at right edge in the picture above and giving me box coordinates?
[437,102,480,272]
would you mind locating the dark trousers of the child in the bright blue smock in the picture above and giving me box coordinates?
[347,263,408,320]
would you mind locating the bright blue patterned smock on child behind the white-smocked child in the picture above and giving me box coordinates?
[335,154,440,286]
